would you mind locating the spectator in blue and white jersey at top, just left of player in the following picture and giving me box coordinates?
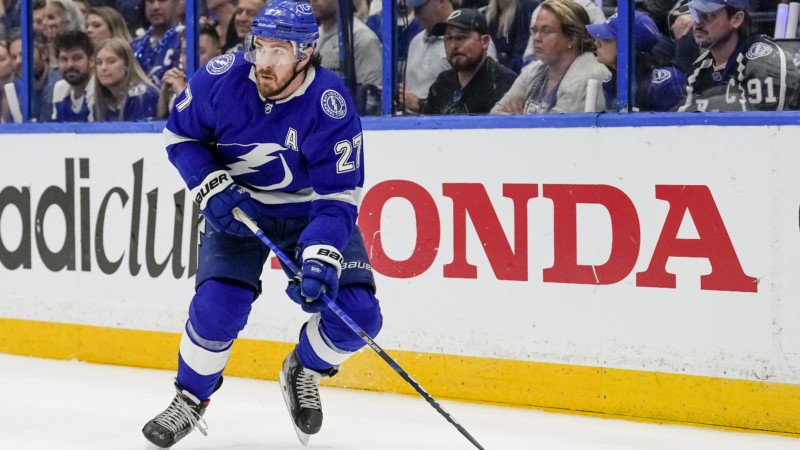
[130,0,183,86]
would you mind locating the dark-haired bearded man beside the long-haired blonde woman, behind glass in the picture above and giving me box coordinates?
[52,31,94,122]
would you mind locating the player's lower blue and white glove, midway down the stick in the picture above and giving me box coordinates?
[286,245,343,313]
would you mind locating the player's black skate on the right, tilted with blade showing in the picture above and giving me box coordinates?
[279,350,338,445]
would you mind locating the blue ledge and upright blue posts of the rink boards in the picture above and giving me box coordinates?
[0,0,800,134]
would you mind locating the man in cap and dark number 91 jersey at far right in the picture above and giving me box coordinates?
[678,0,800,111]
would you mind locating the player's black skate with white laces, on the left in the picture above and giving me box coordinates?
[142,377,222,448]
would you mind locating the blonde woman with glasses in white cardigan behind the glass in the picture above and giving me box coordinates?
[492,0,611,114]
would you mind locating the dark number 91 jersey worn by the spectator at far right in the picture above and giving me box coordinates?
[679,36,800,112]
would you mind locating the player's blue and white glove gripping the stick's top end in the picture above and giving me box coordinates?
[192,170,259,236]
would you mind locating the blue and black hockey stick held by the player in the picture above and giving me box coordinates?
[233,208,484,450]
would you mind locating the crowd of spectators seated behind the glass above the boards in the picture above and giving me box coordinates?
[0,0,800,123]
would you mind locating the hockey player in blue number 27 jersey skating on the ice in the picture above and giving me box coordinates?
[142,0,383,447]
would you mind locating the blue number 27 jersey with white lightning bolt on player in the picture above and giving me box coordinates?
[164,52,364,249]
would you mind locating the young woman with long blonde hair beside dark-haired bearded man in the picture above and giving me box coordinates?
[94,38,158,122]
